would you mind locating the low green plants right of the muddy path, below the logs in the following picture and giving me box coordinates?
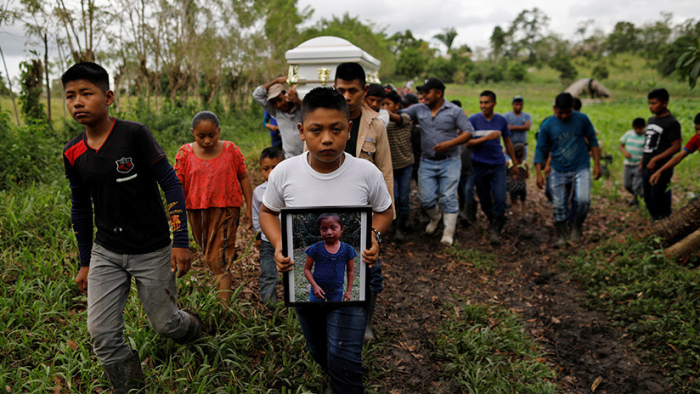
[572,239,700,392]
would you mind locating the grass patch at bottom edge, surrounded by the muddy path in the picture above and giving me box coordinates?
[434,303,556,394]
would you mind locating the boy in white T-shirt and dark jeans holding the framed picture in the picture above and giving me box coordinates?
[260,88,394,393]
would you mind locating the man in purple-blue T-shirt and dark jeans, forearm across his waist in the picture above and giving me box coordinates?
[465,90,514,244]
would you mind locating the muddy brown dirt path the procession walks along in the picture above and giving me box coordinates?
[234,174,671,394]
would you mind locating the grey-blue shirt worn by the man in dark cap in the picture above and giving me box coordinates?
[400,100,474,159]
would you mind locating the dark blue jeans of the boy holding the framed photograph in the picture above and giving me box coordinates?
[296,305,367,394]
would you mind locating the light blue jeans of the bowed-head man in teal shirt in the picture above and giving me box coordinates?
[549,167,591,222]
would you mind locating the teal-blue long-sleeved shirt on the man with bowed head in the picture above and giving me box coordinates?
[535,111,598,172]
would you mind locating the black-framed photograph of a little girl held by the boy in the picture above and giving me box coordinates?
[281,205,372,306]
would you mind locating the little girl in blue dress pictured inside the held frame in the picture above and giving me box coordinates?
[304,213,357,302]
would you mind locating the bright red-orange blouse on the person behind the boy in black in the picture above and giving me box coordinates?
[175,141,246,209]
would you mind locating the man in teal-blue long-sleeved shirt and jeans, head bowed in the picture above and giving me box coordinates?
[535,93,601,247]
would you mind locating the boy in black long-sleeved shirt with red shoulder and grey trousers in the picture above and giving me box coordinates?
[61,62,202,394]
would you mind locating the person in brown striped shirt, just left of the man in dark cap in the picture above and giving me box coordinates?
[382,90,415,242]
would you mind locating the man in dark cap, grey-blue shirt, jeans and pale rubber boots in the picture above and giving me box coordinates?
[402,78,474,245]
